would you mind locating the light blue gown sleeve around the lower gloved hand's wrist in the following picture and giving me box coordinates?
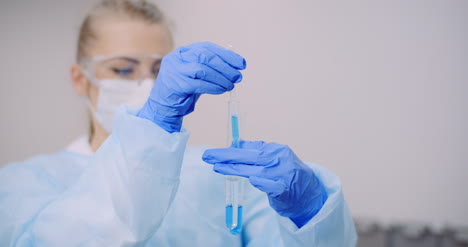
[243,164,357,247]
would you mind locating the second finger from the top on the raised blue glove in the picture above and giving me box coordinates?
[180,48,242,83]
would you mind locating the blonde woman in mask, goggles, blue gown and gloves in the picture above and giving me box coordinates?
[0,0,356,247]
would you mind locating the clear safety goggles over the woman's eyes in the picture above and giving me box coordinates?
[80,54,163,86]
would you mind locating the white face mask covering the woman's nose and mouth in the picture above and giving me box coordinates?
[89,79,154,134]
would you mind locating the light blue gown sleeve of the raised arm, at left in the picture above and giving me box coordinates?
[0,107,188,246]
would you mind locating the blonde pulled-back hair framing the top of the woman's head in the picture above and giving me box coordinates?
[76,0,172,62]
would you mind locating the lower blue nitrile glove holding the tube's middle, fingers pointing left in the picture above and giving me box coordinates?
[203,141,327,227]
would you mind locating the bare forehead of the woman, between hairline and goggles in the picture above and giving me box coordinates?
[89,17,172,56]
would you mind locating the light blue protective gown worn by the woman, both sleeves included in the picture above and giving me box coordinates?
[0,108,356,247]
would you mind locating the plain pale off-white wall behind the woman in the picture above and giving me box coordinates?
[0,0,468,227]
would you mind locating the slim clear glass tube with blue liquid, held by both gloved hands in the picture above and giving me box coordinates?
[226,90,245,235]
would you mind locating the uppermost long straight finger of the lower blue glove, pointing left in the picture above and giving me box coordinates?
[202,148,271,166]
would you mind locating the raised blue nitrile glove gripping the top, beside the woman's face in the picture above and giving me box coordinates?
[137,42,246,133]
